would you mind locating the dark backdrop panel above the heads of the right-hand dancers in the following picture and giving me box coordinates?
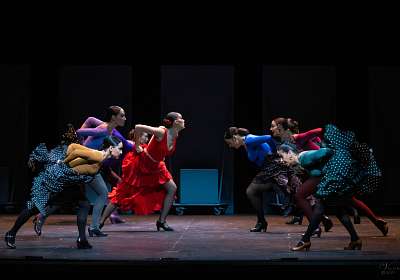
[262,65,336,133]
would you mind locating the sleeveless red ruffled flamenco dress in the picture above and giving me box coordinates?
[108,129,176,215]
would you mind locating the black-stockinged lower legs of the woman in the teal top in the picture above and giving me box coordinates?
[301,199,359,242]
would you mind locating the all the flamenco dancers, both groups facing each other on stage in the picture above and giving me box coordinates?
[5,106,388,251]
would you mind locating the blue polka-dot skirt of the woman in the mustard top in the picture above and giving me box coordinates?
[27,143,93,215]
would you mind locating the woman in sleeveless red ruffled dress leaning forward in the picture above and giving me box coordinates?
[100,112,185,231]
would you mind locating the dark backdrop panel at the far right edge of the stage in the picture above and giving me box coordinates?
[367,67,400,214]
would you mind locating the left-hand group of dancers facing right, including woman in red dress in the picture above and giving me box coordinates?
[5,106,185,249]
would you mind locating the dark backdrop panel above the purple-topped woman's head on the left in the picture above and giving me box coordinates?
[54,65,133,136]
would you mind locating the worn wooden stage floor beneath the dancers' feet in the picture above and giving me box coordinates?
[0,215,400,261]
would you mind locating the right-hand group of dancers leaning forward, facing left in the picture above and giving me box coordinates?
[224,117,389,251]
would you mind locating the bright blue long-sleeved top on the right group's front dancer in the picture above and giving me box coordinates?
[244,134,276,167]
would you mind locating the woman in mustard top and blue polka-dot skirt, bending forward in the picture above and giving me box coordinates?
[5,126,122,249]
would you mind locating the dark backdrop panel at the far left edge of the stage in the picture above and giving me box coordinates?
[0,65,32,206]
